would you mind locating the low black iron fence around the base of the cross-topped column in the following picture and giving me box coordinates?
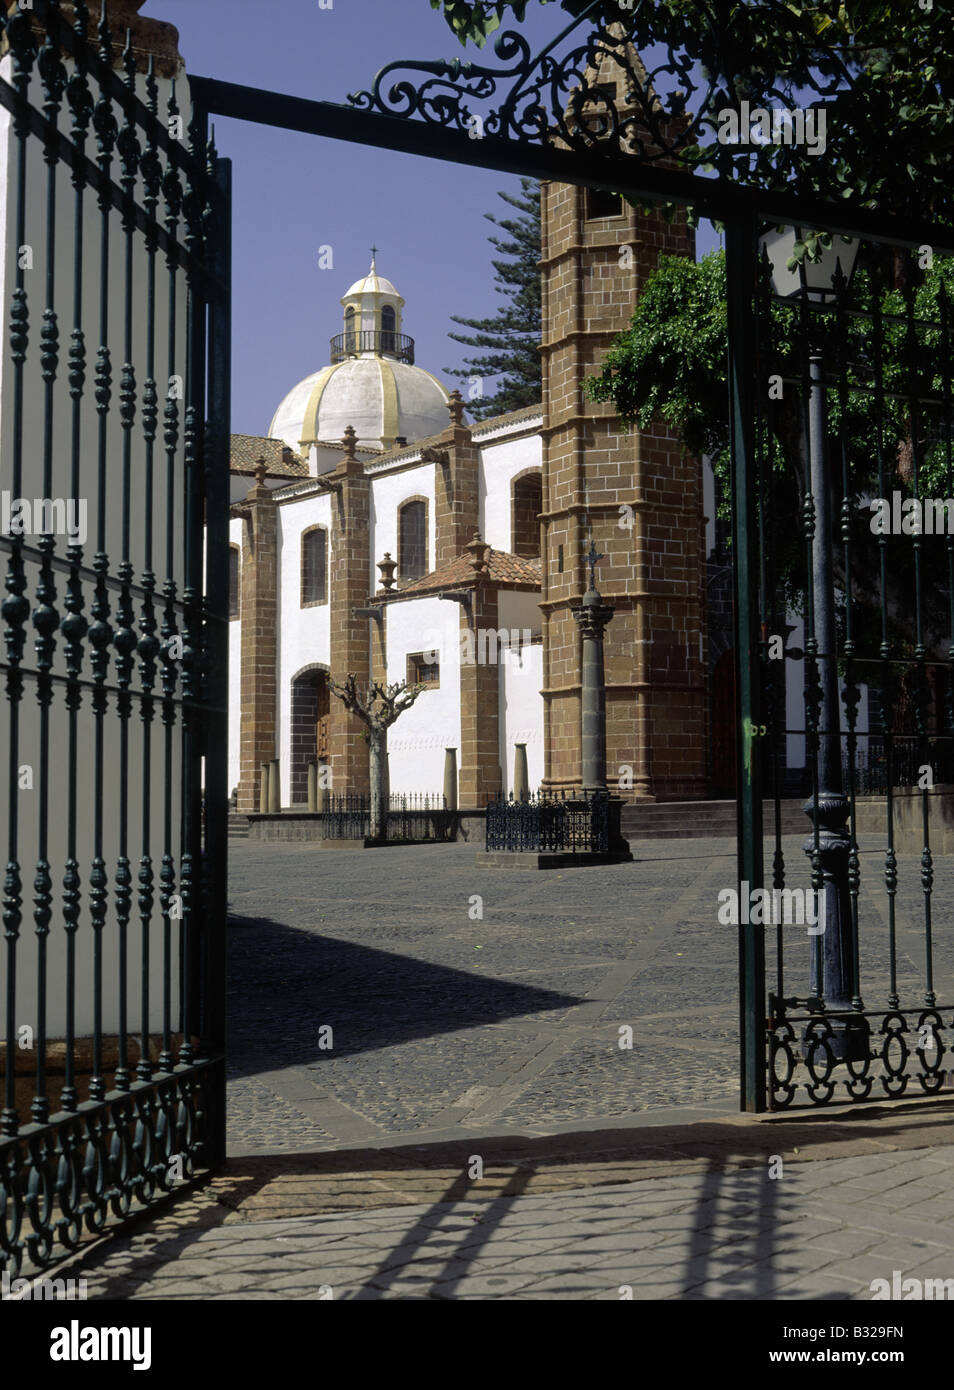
[485,794,609,853]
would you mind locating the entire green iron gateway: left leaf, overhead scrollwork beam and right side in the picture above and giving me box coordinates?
[0,0,954,1269]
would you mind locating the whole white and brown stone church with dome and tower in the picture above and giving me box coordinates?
[229,168,731,813]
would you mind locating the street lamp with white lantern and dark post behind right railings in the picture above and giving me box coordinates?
[762,228,866,1059]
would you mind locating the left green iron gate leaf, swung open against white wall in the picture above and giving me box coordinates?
[0,0,229,1273]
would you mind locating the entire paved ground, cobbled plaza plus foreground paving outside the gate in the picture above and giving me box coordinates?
[46,837,954,1301]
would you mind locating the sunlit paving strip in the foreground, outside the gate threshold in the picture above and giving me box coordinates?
[70,1134,954,1301]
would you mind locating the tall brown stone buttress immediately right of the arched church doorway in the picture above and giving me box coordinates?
[325,425,371,796]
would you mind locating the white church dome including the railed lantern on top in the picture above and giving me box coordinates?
[268,260,449,455]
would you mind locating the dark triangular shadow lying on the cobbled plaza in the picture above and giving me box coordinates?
[228,915,585,1076]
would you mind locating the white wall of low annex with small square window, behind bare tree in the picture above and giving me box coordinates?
[387,594,460,794]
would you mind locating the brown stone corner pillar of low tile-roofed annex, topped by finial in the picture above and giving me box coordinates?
[460,535,501,810]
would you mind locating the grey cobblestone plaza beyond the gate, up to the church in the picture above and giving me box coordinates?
[229,837,954,1155]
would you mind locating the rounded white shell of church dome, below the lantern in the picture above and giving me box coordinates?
[268,354,449,455]
